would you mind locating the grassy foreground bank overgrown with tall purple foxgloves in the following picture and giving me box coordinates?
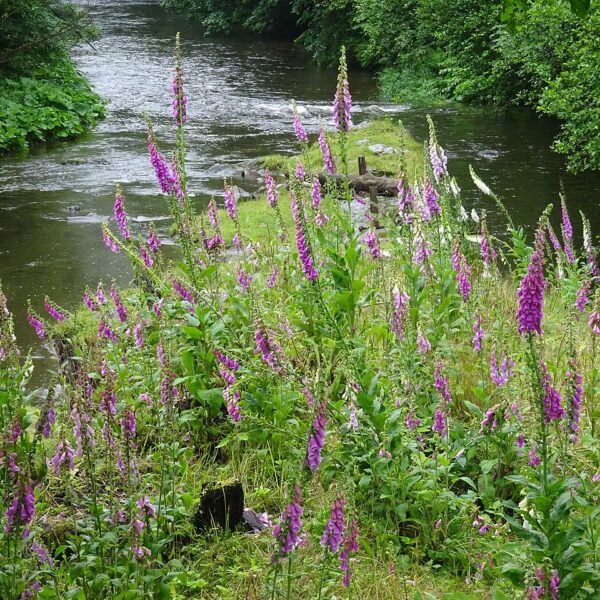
[0,47,600,600]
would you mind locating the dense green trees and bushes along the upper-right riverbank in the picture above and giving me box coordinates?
[163,0,600,172]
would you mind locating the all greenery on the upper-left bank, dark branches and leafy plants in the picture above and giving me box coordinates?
[0,0,105,153]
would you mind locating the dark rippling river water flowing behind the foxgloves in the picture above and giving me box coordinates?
[0,0,600,367]
